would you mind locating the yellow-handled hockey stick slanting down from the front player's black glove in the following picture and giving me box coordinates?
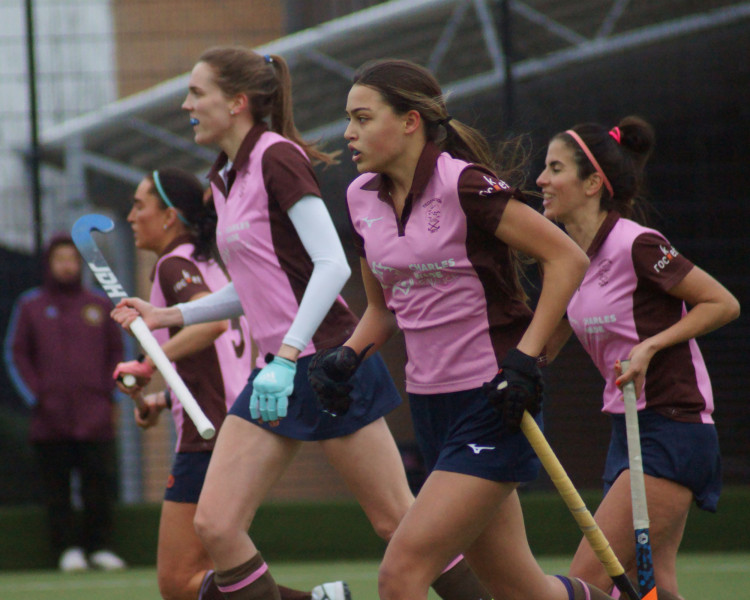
[497,381,641,600]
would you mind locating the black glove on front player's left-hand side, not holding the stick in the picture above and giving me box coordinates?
[307,344,373,417]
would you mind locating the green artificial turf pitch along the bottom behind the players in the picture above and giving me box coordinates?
[0,553,750,600]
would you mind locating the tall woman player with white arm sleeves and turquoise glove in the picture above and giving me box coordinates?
[110,48,488,600]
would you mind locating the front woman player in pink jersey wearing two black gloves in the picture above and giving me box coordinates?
[311,60,624,600]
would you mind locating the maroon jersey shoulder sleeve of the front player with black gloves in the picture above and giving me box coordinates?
[458,165,523,235]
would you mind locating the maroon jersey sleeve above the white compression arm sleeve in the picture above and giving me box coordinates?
[263,142,322,212]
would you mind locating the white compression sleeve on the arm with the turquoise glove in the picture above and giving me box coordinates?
[283,196,352,350]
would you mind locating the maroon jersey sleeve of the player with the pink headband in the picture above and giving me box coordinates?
[632,233,694,292]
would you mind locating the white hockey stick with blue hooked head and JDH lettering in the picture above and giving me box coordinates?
[71,214,216,439]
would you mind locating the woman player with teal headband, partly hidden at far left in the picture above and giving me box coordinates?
[115,168,342,600]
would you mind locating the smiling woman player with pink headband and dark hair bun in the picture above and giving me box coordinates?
[537,117,739,595]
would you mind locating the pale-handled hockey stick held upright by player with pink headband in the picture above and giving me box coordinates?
[620,360,658,600]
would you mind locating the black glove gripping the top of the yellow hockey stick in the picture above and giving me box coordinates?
[482,348,544,431]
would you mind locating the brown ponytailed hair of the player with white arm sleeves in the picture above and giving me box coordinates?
[198,46,339,165]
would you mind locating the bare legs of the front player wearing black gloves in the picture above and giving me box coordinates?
[378,471,567,600]
